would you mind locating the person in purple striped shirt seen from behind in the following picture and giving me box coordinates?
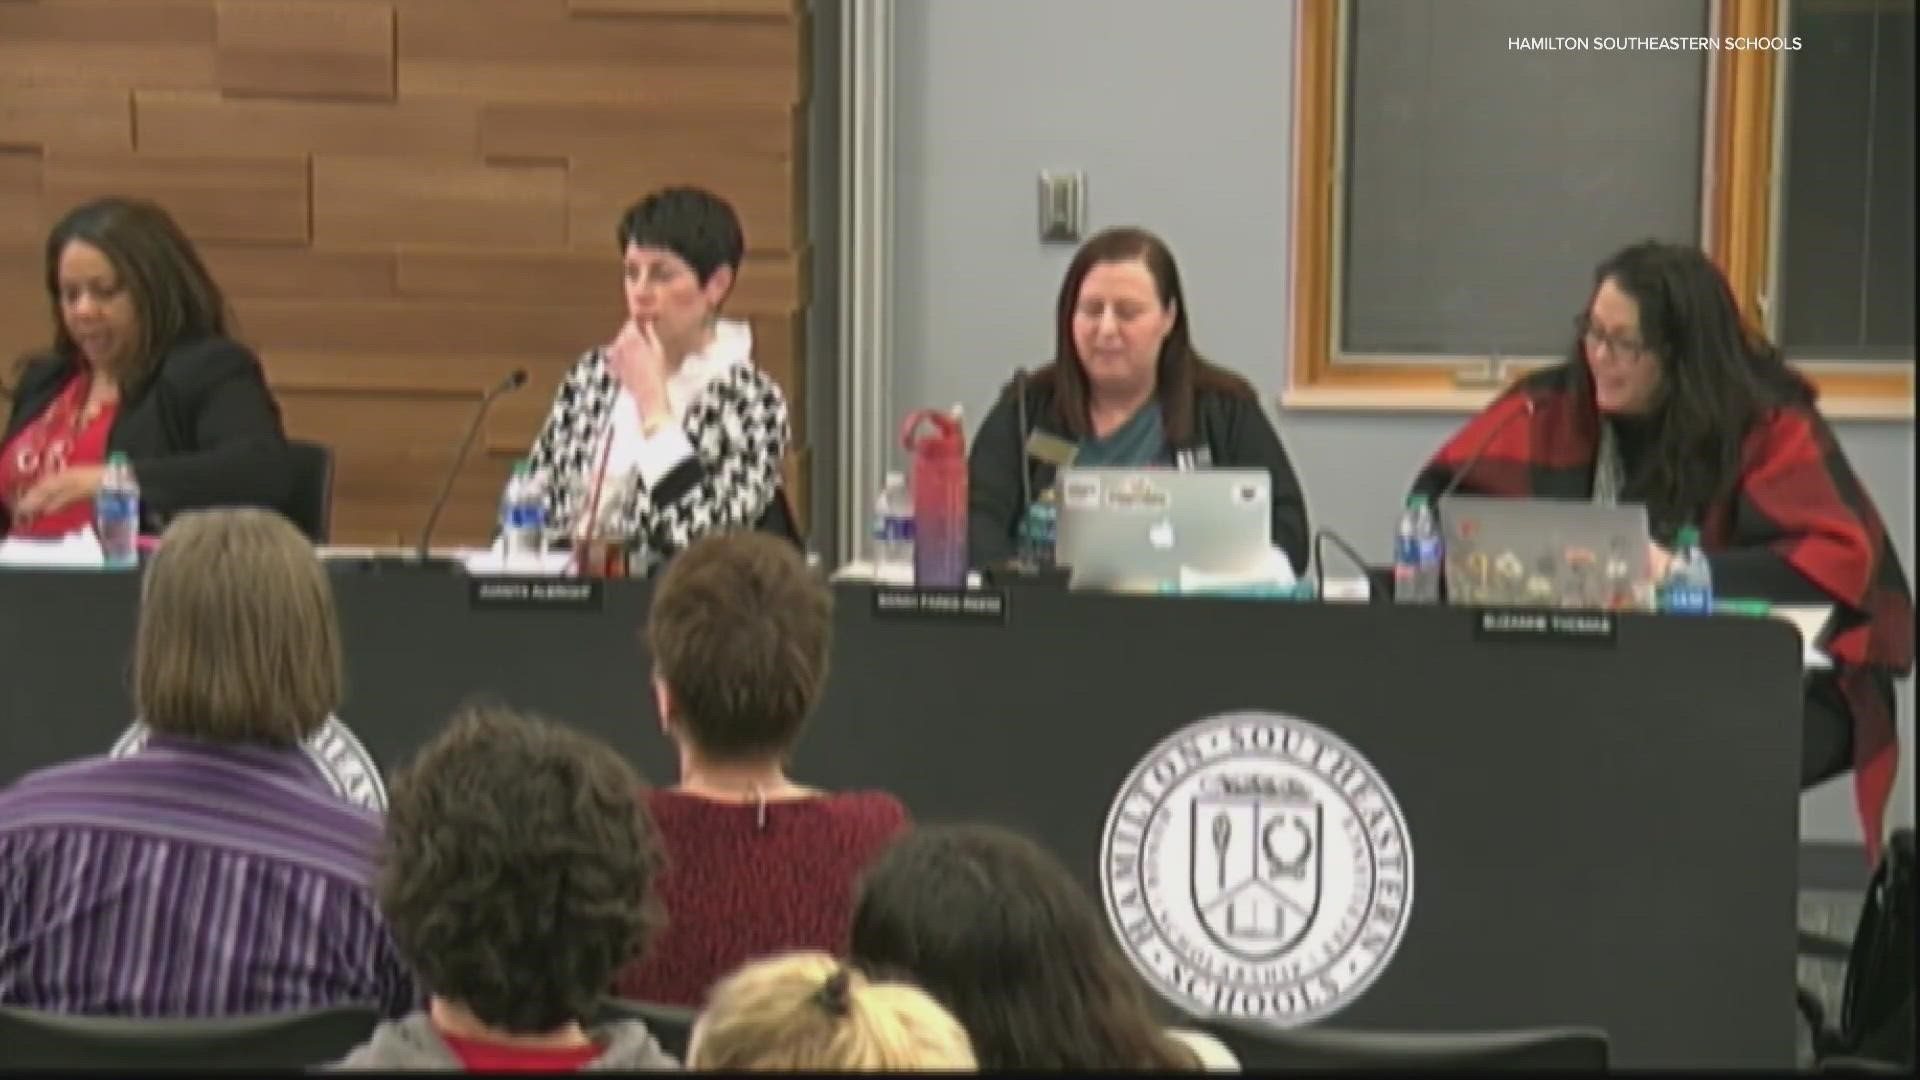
[0,509,417,1014]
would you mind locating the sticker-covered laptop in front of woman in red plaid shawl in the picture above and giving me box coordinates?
[1440,496,1653,611]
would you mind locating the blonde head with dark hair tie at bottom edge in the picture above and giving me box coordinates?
[687,953,975,1072]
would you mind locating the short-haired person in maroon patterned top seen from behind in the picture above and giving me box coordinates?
[614,532,908,1005]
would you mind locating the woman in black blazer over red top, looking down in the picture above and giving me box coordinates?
[0,198,292,536]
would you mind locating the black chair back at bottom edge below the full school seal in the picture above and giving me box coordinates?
[1185,1019,1607,1072]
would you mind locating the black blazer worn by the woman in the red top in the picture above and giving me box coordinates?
[0,338,292,536]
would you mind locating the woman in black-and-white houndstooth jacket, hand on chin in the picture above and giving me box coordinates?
[530,188,799,577]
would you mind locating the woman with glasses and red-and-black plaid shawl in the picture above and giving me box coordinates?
[1415,240,1912,846]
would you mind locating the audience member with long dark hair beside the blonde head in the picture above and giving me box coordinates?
[849,824,1240,1072]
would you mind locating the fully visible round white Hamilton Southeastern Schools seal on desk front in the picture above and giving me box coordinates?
[1100,711,1413,1028]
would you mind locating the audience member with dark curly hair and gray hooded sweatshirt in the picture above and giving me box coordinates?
[334,705,680,1072]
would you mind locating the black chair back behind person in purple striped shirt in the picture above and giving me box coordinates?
[0,1005,380,1072]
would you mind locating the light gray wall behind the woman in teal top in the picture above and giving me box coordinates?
[891,0,1914,840]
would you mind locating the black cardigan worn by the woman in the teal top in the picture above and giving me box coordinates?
[968,379,1308,573]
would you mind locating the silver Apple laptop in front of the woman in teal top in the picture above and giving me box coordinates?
[1054,467,1273,588]
